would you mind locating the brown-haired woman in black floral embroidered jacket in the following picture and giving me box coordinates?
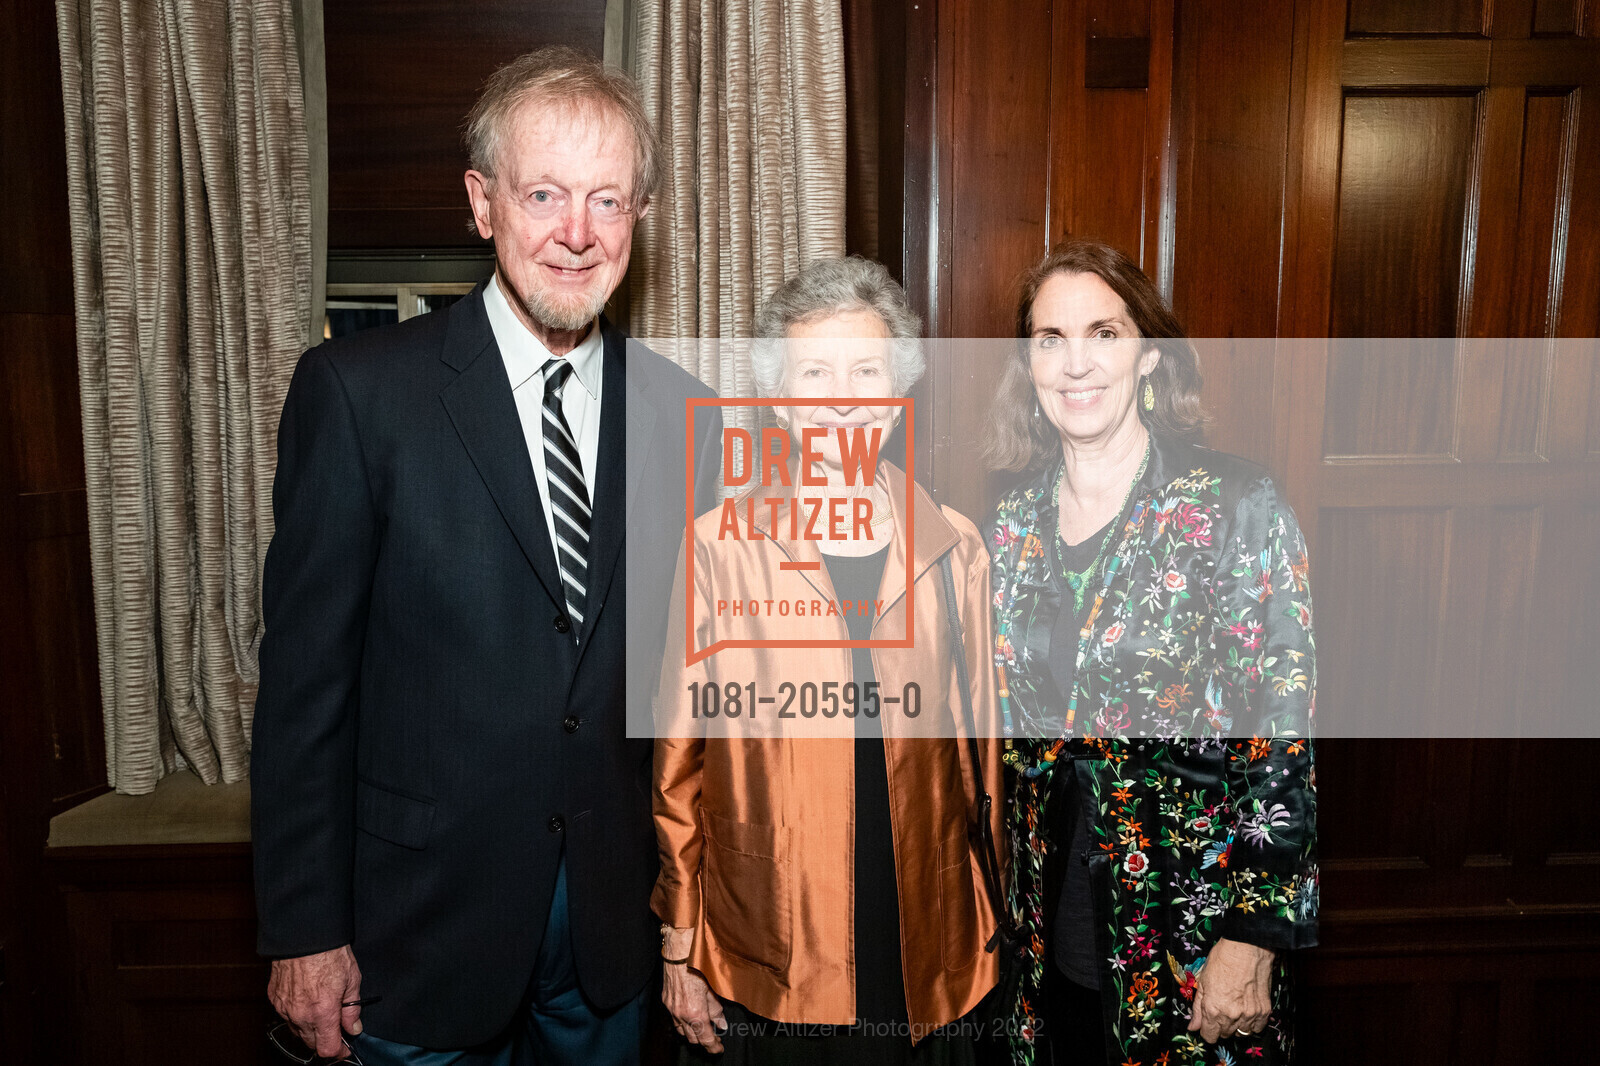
[984,242,1317,1066]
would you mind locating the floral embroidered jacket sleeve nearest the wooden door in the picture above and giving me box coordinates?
[1214,477,1318,951]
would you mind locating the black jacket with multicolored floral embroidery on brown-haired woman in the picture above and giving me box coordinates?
[987,440,1317,1066]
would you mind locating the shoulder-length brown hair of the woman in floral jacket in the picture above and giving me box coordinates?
[984,238,1205,471]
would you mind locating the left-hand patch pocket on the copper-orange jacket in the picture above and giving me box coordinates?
[701,807,792,972]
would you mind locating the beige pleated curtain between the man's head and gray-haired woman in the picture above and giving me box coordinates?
[626,0,846,393]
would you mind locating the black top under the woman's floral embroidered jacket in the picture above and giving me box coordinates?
[1050,515,1122,988]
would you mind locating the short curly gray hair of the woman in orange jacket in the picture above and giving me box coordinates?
[750,256,926,395]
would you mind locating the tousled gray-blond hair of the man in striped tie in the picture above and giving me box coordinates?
[461,45,661,208]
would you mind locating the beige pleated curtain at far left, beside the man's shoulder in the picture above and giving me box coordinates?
[56,0,326,794]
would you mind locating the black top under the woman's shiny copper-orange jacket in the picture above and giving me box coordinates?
[822,547,909,1023]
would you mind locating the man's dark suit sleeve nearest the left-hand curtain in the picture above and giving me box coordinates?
[250,349,378,957]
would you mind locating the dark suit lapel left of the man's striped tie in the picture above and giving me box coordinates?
[435,285,566,608]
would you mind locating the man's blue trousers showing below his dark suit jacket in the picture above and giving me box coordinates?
[347,858,651,1066]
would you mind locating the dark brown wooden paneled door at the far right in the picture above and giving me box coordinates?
[1275,0,1600,1063]
